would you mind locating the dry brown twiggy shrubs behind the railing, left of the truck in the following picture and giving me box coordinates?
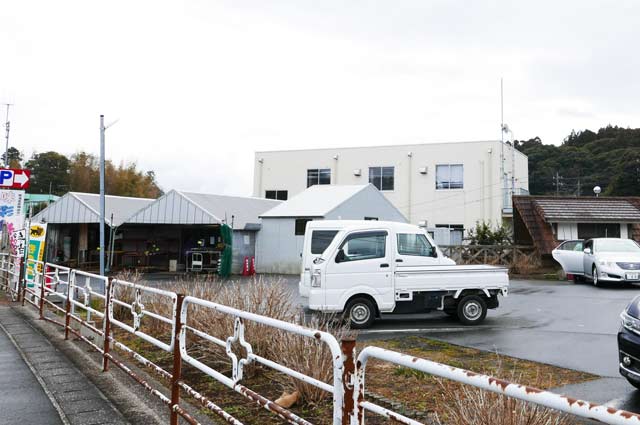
[137,277,352,404]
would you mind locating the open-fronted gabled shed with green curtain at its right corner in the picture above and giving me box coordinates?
[125,190,281,273]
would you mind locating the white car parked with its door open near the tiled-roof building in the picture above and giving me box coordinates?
[552,238,640,286]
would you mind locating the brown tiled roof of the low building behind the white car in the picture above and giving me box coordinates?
[533,197,640,223]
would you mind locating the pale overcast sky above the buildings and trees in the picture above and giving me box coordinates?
[0,0,640,195]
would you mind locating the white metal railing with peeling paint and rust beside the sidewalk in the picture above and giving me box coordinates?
[0,254,640,425]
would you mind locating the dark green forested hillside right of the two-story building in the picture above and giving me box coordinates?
[516,126,640,196]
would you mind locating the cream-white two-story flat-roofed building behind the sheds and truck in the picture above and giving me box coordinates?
[253,140,529,242]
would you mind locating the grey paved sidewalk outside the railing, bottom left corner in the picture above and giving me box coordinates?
[0,297,128,425]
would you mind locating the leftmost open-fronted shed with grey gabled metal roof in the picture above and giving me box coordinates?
[31,192,153,267]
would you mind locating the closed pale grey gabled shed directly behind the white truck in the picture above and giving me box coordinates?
[256,184,407,274]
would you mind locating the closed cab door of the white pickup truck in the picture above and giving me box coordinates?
[325,230,394,310]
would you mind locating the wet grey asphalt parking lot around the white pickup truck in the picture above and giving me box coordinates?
[286,276,640,412]
